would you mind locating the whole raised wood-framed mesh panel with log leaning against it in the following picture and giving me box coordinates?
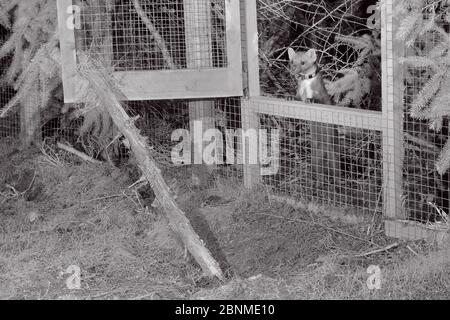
[58,0,242,102]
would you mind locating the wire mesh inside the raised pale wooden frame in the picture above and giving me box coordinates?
[75,0,227,71]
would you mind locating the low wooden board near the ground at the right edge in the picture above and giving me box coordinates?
[384,220,450,247]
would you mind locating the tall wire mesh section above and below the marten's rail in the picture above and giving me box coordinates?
[243,1,383,213]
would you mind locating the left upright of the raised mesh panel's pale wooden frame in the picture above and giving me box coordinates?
[56,0,80,103]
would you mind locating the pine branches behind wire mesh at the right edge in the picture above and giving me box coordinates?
[396,0,450,175]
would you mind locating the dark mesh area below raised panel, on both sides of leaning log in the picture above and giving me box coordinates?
[34,98,242,177]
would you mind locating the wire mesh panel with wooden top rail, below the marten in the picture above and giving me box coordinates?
[243,98,383,213]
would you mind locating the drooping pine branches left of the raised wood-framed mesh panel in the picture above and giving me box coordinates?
[0,0,115,155]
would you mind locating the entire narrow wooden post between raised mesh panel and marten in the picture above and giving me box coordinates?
[238,0,261,188]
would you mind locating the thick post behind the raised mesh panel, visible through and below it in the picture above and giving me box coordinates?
[183,0,215,186]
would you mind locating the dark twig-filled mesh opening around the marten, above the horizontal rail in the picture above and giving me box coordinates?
[258,0,382,111]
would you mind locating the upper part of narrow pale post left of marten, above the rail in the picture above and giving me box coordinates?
[244,0,261,97]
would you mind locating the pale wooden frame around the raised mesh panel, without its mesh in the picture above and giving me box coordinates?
[57,0,242,103]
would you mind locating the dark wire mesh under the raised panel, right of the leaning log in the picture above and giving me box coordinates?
[125,98,242,176]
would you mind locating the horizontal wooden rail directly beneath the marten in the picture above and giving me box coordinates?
[247,97,384,131]
